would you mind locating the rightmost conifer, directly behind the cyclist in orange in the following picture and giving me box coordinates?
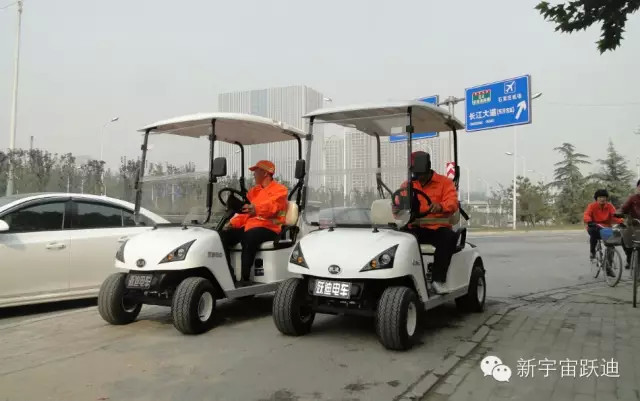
[593,140,633,206]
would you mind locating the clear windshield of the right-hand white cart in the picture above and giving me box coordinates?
[304,131,420,226]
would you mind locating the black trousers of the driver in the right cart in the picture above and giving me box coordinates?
[409,227,456,283]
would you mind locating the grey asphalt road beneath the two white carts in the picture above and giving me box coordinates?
[0,233,591,401]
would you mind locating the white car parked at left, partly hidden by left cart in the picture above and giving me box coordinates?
[0,193,168,307]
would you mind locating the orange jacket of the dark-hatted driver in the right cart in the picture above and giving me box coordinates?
[402,171,458,230]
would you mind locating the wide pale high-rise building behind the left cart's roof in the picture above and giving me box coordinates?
[215,85,324,183]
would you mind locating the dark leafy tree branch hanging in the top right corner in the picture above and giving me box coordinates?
[535,0,640,54]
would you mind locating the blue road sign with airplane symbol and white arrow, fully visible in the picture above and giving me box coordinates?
[465,75,531,132]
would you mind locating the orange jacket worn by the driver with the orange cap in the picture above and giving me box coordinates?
[230,181,288,234]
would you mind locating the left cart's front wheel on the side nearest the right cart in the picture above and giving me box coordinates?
[171,277,216,334]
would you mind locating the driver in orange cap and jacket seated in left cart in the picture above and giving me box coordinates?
[220,160,288,285]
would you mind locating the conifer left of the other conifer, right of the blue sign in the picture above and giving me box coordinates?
[552,142,591,224]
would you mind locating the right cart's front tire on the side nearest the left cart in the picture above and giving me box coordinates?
[273,277,316,336]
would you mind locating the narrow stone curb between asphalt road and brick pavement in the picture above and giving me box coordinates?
[394,302,524,401]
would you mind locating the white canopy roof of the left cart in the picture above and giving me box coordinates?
[138,113,307,145]
